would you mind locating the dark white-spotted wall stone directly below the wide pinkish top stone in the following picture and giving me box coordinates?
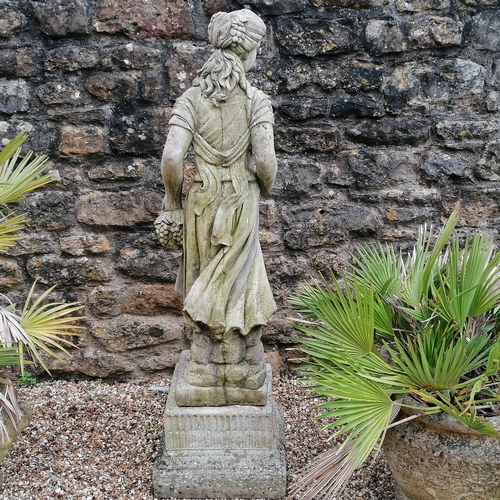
[100,42,161,70]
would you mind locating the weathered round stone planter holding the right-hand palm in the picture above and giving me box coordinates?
[383,408,500,500]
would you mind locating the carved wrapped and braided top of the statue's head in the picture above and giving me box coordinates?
[208,9,266,57]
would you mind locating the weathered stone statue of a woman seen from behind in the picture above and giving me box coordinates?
[160,9,276,406]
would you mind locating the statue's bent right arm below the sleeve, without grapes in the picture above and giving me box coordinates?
[252,122,277,194]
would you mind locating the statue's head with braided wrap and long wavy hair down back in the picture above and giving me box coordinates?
[193,9,266,106]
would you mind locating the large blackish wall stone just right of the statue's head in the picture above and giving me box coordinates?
[276,18,360,57]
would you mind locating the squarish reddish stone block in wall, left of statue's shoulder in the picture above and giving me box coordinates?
[59,125,106,156]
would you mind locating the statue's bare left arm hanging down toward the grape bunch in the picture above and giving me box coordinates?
[161,125,193,210]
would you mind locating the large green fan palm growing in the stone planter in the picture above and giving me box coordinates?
[291,213,500,499]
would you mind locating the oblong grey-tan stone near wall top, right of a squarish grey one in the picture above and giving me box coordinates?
[408,15,464,49]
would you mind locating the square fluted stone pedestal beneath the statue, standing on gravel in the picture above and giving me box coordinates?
[153,354,286,498]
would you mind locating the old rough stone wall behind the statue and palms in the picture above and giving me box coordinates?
[0,0,500,377]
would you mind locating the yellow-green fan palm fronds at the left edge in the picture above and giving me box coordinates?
[0,132,83,450]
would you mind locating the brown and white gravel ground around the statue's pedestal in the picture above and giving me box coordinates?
[0,377,394,500]
